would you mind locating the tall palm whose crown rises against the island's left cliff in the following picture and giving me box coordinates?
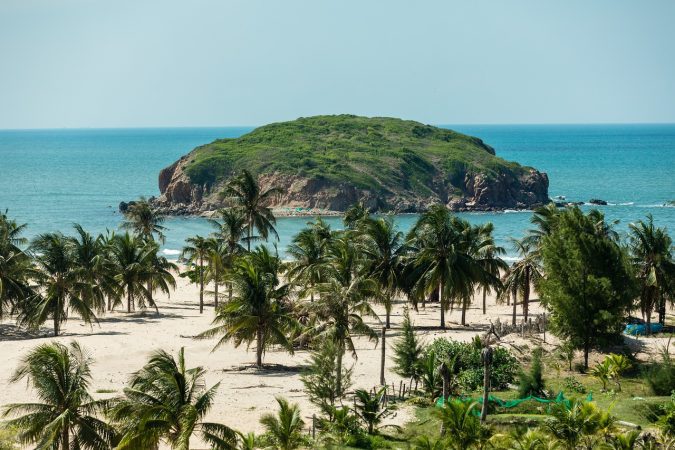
[222,169,282,251]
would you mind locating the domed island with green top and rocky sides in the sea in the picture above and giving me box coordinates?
[153,115,550,215]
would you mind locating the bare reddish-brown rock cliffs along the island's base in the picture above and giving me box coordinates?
[154,155,550,215]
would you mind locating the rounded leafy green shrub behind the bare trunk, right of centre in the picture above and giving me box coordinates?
[425,338,519,391]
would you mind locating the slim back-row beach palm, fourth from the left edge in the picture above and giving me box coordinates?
[109,233,158,313]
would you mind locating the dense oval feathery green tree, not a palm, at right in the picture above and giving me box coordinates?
[538,208,635,367]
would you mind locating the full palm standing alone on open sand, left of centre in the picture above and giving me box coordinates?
[198,247,296,368]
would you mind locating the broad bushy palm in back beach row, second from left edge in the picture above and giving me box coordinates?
[22,233,98,336]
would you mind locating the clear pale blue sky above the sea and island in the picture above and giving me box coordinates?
[0,0,675,128]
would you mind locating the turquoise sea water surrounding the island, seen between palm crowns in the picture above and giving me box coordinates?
[0,124,675,258]
